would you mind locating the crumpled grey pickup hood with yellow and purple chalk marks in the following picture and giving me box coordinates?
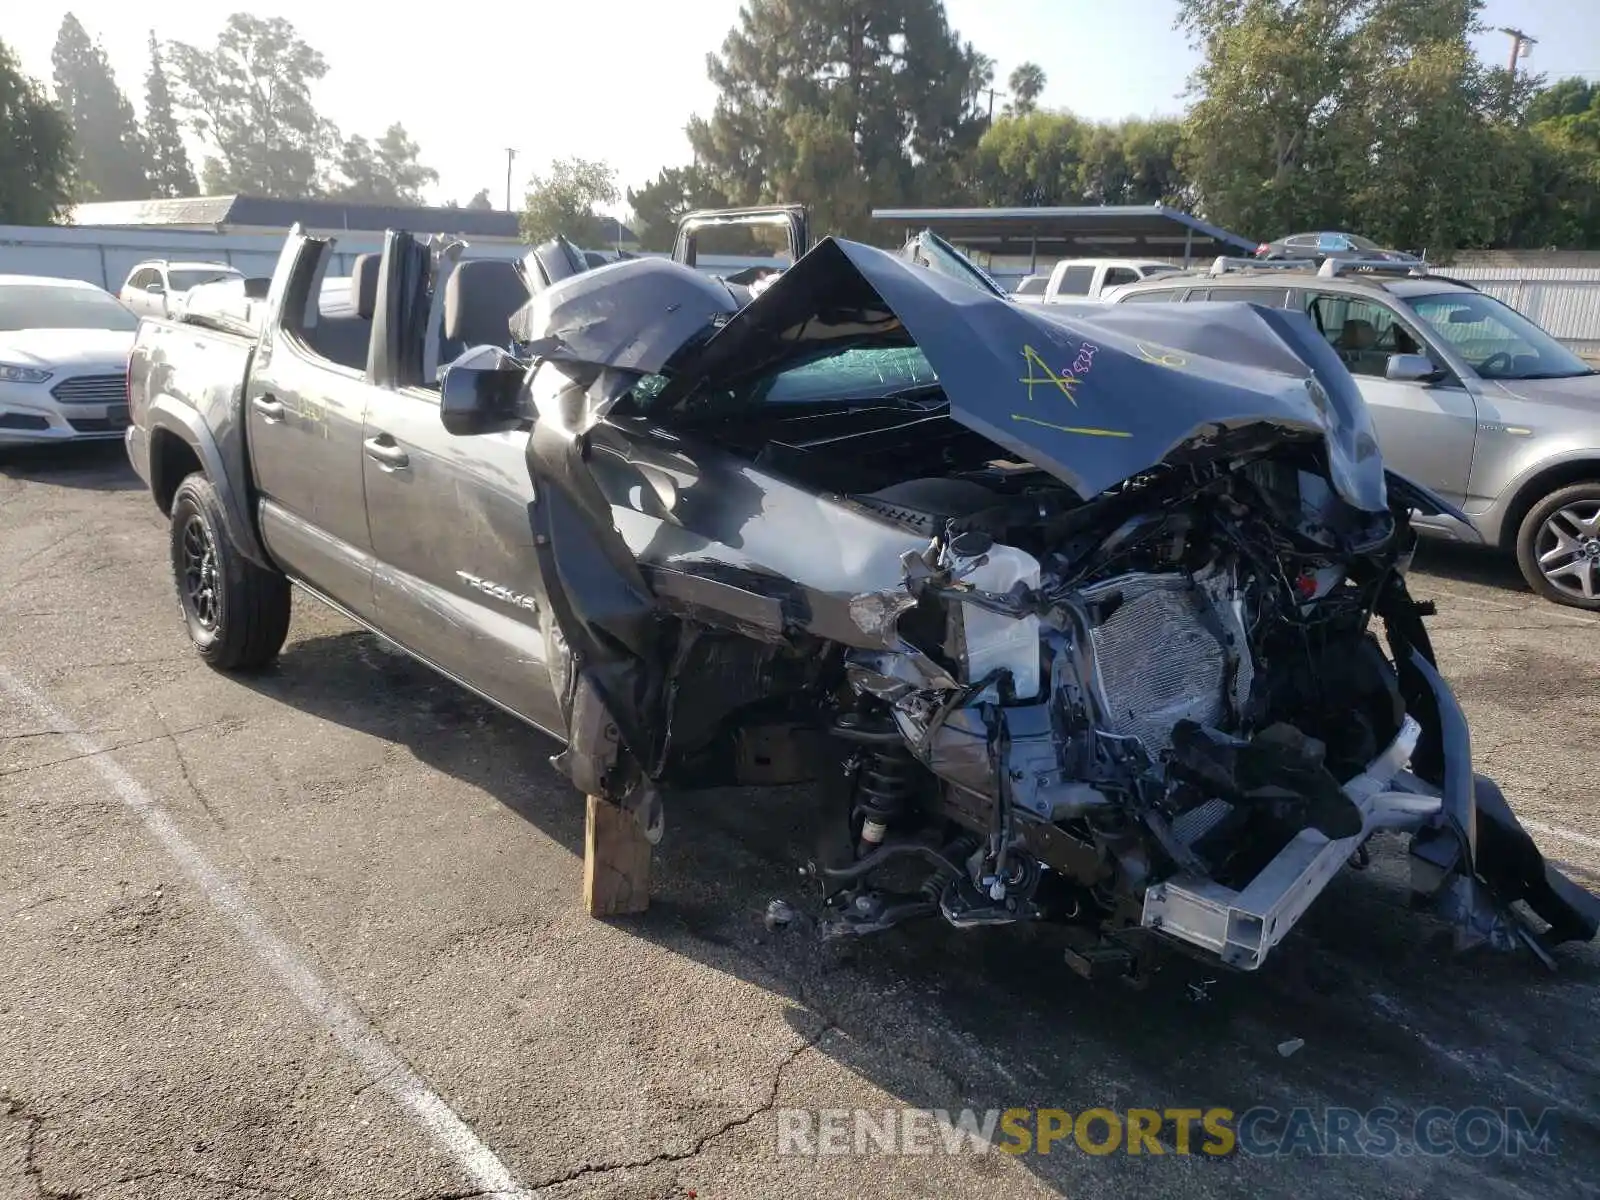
[661,238,1387,512]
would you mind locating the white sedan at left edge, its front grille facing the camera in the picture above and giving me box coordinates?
[0,275,139,446]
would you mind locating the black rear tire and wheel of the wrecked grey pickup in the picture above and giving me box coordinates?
[170,472,290,670]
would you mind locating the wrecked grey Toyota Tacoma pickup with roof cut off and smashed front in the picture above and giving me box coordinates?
[130,210,1600,974]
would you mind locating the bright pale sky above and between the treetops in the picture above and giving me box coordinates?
[12,0,1600,214]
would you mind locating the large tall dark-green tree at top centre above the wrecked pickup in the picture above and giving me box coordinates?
[688,0,992,235]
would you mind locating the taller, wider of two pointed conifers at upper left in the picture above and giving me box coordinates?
[50,13,150,200]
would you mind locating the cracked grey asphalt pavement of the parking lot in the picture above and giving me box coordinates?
[0,445,1600,1200]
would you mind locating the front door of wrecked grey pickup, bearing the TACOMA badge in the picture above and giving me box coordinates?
[362,244,562,731]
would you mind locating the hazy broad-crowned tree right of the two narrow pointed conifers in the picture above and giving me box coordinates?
[171,13,339,197]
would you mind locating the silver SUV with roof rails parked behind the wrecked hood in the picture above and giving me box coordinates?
[1107,259,1600,610]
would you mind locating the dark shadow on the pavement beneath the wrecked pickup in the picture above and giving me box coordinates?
[236,632,1600,1197]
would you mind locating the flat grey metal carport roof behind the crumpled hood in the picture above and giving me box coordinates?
[872,205,1258,266]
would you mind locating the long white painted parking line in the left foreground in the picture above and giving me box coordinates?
[0,667,530,1200]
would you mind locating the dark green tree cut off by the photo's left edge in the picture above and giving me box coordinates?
[0,42,74,226]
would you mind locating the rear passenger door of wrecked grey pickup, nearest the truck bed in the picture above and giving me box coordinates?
[245,229,376,619]
